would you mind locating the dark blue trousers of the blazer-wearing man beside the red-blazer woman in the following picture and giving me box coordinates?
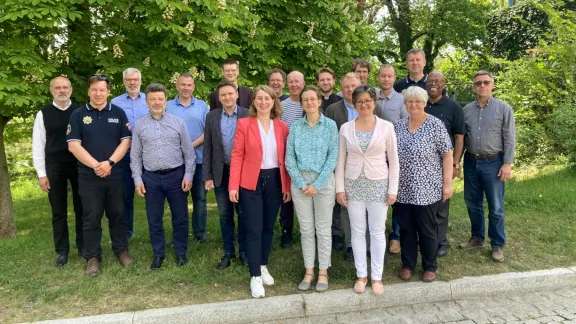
[214,167,246,256]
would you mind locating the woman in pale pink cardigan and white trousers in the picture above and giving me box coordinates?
[336,86,399,295]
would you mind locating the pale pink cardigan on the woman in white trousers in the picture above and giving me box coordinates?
[336,117,400,195]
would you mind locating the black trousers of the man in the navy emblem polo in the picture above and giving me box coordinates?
[78,176,128,260]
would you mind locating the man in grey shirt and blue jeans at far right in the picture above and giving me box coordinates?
[461,71,516,262]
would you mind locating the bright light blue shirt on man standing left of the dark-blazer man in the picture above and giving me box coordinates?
[166,96,210,164]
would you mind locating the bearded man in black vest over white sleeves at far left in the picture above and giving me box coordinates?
[32,77,84,267]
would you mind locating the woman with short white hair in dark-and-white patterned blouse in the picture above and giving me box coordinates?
[394,87,452,282]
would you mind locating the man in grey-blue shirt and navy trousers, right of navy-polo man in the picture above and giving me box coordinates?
[130,83,196,270]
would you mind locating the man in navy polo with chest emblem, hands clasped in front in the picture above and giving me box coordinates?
[66,74,133,277]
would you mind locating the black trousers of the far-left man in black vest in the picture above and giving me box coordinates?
[46,161,84,254]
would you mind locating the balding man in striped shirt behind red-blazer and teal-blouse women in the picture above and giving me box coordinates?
[280,71,306,248]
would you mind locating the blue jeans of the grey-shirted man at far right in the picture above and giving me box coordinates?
[464,155,506,248]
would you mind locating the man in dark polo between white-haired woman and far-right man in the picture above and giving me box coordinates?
[425,71,466,257]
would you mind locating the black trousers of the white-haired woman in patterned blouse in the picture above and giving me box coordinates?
[394,201,441,272]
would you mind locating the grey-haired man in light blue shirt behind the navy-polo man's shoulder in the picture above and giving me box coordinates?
[111,68,148,240]
